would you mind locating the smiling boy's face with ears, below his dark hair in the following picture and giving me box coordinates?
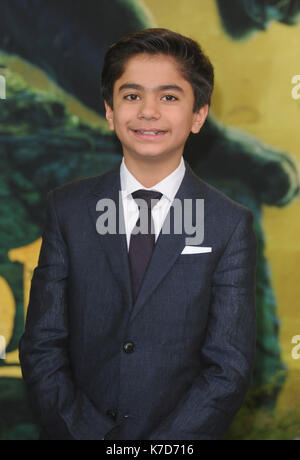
[105,54,208,164]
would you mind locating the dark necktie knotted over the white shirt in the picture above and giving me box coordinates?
[129,190,162,301]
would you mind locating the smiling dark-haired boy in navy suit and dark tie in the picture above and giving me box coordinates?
[20,29,256,440]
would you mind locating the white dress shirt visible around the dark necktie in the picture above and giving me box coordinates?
[120,157,186,251]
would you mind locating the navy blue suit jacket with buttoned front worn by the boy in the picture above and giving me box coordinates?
[20,162,256,440]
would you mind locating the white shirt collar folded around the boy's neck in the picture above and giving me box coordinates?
[120,157,186,202]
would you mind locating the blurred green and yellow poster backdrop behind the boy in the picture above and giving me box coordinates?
[0,0,300,440]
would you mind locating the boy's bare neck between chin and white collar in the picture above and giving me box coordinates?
[124,154,181,188]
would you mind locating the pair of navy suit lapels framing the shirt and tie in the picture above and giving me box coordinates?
[87,161,204,321]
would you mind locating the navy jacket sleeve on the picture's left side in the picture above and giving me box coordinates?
[19,191,115,440]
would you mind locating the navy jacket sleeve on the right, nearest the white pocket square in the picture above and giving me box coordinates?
[148,210,257,440]
